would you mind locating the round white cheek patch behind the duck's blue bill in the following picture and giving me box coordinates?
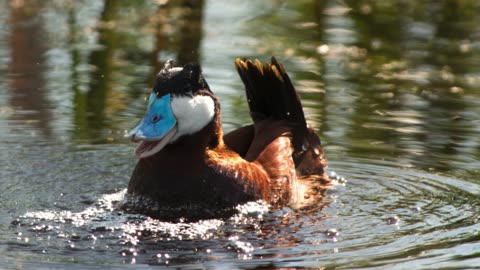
[171,95,215,142]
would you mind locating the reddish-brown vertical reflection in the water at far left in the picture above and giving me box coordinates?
[8,1,52,138]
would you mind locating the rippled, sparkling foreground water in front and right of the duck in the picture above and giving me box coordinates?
[4,159,480,269]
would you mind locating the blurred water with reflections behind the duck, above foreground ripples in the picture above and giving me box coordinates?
[0,0,480,266]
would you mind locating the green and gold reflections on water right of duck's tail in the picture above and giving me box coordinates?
[238,1,480,171]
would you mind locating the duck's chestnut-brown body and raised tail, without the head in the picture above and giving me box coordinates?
[123,57,329,220]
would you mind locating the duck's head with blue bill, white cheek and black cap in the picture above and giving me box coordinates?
[126,61,215,158]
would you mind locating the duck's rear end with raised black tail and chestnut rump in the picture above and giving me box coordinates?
[235,57,328,204]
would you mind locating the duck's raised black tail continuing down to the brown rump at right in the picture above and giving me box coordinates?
[235,57,326,176]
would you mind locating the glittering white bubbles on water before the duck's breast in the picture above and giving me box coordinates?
[12,190,231,263]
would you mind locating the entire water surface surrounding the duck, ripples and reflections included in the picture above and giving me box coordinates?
[0,0,480,269]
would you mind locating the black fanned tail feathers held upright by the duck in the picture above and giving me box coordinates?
[235,57,308,156]
